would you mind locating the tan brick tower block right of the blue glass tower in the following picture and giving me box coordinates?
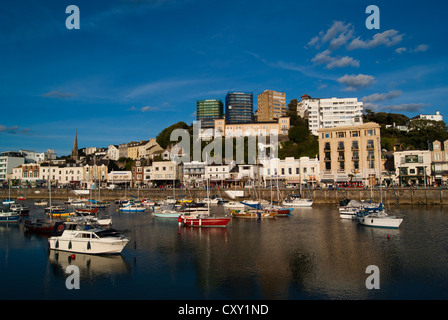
[256,90,287,122]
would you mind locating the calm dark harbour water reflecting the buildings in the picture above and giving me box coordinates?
[0,201,448,300]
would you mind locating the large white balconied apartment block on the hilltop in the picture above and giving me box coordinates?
[297,95,363,135]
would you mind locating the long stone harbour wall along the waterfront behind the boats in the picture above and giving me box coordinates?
[0,188,448,205]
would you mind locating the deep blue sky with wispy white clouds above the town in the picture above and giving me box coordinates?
[0,0,448,155]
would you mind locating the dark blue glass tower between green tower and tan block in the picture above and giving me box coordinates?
[226,92,254,123]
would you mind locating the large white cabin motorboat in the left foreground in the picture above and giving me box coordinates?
[48,222,129,254]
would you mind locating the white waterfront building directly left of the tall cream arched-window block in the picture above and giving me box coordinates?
[260,157,320,187]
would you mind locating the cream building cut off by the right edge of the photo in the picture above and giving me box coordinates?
[430,140,448,186]
